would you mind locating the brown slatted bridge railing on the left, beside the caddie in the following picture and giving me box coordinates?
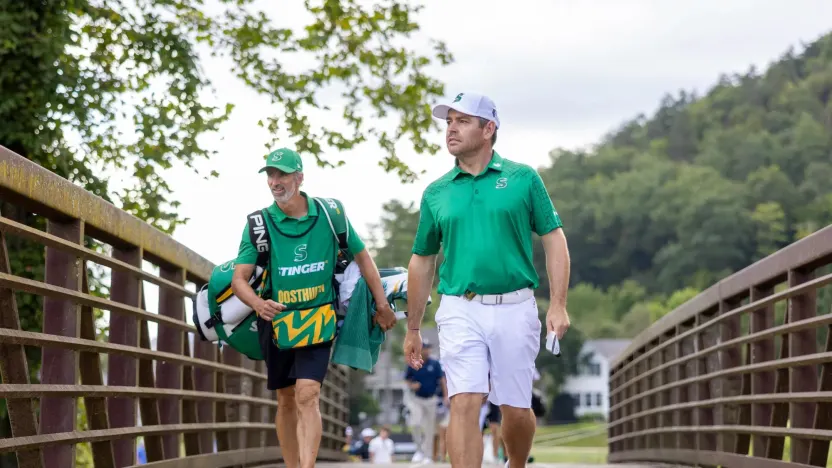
[0,146,347,468]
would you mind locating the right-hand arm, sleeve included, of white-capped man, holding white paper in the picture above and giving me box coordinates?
[529,171,571,339]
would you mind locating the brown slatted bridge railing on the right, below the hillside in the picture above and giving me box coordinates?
[608,226,832,468]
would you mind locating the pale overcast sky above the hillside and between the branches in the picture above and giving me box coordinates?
[150,0,832,263]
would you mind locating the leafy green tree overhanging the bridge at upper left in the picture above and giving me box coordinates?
[0,0,452,460]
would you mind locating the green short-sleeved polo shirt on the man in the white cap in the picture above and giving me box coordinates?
[413,151,563,296]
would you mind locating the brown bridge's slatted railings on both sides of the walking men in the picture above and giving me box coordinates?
[0,147,832,468]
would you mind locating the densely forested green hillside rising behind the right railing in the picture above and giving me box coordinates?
[370,35,832,338]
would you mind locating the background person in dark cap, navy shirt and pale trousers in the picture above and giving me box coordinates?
[404,339,448,463]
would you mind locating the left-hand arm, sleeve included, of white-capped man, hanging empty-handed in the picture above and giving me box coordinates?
[404,195,442,369]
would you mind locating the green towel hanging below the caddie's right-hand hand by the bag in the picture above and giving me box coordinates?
[332,278,385,372]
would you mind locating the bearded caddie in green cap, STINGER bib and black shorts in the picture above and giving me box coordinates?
[231,148,396,468]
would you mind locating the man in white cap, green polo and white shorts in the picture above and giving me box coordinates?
[404,93,569,468]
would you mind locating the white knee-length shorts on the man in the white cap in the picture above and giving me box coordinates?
[436,295,541,408]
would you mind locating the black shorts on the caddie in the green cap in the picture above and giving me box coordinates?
[257,319,333,390]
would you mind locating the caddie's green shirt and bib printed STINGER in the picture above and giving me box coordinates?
[236,192,364,309]
